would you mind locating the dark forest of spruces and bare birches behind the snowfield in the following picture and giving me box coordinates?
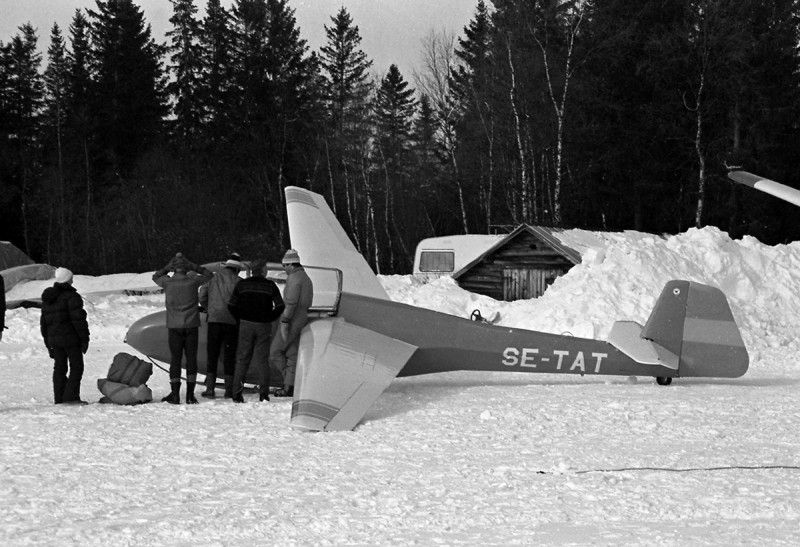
[0,0,800,274]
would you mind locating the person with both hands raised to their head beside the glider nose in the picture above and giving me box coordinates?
[153,253,212,405]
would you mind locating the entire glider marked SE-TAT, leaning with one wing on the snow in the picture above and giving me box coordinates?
[126,186,749,431]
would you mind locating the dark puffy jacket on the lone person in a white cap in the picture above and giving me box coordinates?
[39,283,89,348]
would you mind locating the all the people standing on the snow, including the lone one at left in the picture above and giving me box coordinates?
[34,249,314,404]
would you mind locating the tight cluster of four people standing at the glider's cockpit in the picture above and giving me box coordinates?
[148,249,314,404]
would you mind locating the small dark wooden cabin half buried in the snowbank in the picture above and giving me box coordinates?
[453,224,581,301]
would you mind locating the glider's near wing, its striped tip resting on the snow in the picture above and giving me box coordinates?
[291,318,417,431]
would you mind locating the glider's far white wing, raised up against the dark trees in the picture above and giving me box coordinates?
[286,186,389,300]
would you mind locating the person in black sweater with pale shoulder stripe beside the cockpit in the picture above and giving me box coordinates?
[228,260,284,403]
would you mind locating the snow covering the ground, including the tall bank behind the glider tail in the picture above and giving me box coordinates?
[0,228,800,546]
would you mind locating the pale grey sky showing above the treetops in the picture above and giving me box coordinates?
[0,0,477,81]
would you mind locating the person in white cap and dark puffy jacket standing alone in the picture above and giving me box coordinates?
[39,268,89,404]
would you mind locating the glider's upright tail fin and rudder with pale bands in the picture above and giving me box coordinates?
[641,281,750,378]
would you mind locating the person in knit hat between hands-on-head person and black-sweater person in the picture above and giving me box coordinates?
[200,254,242,399]
